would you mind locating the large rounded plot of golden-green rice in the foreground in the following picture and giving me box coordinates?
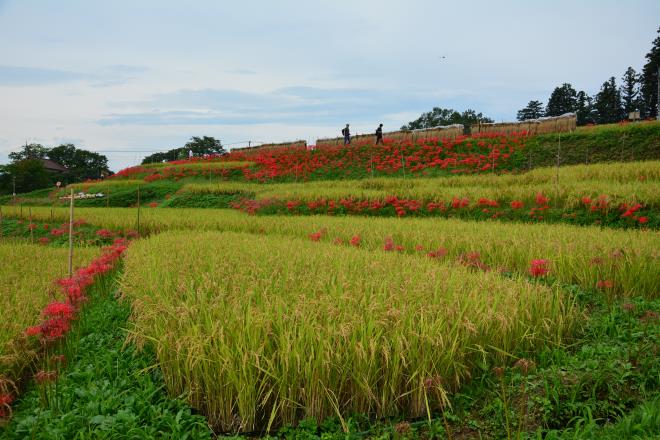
[122,232,576,431]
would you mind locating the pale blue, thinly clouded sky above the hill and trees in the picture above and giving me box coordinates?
[0,0,660,171]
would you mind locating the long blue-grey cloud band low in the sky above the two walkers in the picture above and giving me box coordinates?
[98,86,471,125]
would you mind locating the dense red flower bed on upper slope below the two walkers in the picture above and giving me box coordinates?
[223,132,527,181]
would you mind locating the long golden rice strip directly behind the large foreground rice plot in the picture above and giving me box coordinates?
[4,208,660,297]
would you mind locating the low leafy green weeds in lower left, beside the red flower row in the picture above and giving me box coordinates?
[0,276,210,440]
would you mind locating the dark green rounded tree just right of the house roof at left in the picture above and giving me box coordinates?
[48,144,110,182]
